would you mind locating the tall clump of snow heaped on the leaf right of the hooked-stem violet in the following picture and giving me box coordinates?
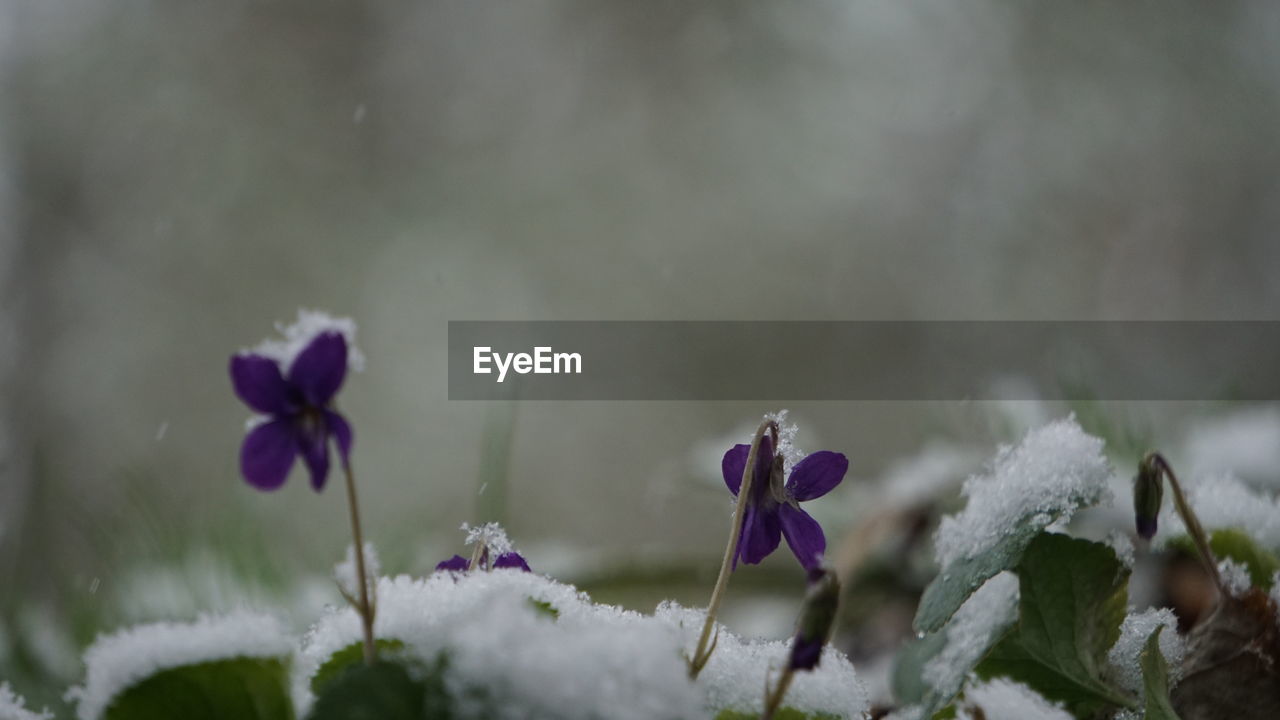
[934,416,1112,569]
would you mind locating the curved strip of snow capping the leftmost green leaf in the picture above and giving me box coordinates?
[67,610,293,720]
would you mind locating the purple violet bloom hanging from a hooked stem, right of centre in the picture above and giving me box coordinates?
[721,436,849,570]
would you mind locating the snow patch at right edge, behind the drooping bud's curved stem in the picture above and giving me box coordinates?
[1156,475,1280,550]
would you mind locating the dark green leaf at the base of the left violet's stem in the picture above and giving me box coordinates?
[308,660,437,720]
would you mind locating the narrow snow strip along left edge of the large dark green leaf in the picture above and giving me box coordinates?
[924,570,1019,696]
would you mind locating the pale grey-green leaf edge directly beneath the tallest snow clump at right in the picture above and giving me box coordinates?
[913,524,1039,633]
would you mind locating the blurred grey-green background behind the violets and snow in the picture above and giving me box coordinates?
[0,0,1280,707]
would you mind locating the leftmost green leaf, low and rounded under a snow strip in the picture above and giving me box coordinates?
[105,657,293,720]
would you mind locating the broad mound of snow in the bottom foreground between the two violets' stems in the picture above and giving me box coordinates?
[294,573,867,720]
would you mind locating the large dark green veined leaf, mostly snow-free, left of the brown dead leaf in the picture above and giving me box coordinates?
[978,533,1135,716]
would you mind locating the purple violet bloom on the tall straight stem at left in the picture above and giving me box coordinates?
[230,331,352,492]
